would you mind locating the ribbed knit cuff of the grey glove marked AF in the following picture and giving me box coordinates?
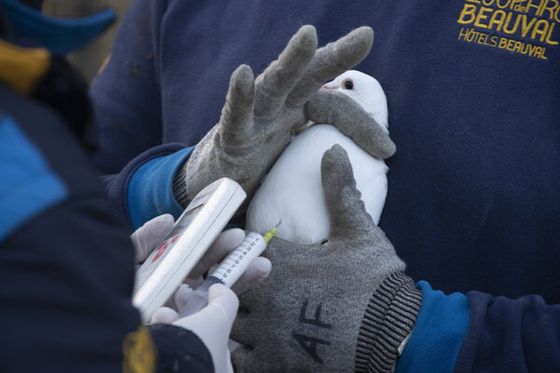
[356,272,422,372]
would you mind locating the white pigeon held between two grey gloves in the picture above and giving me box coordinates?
[246,70,388,244]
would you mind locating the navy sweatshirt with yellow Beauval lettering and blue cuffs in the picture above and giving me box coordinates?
[92,0,560,372]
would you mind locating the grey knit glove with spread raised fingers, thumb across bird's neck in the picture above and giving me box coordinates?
[174,26,395,205]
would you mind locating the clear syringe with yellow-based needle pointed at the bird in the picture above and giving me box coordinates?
[179,227,276,317]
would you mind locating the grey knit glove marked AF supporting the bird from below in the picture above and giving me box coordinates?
[231,145,421,372]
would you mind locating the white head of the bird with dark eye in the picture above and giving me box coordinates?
[323,70,389,129]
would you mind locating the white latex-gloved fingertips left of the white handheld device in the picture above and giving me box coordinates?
[130,214,175,264]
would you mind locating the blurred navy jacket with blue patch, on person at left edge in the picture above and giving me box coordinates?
[0,52,213,372]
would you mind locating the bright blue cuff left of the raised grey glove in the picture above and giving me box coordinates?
[127,147,194,229]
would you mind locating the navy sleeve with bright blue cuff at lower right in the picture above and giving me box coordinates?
[396,281,560,372]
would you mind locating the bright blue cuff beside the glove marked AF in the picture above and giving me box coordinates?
[395,281,469,373]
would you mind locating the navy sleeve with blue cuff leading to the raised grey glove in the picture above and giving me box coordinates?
[90,0,196,228]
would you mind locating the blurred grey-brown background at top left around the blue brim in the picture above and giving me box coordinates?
[43,0,132,81]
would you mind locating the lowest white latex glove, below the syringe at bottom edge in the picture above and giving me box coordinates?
[173,284,239,373]
